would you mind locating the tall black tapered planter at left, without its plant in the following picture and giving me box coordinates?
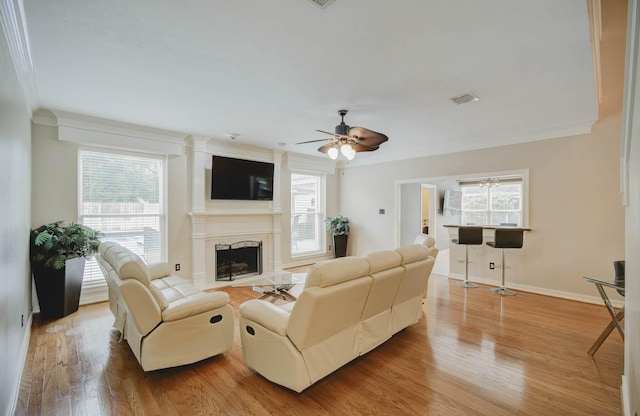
[31,257,85,319]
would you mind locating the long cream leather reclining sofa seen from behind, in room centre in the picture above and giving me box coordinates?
[240,244,435,392]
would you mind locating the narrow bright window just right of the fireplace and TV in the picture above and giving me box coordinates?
[291,173,326,257]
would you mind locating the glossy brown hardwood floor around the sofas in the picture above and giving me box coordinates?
[16,275,623,416]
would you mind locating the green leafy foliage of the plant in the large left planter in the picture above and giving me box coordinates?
[31,221,102,270]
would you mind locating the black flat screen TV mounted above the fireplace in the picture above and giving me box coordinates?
[211,155,273,201]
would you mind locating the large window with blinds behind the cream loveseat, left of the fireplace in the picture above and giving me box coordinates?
[78,149,166,282]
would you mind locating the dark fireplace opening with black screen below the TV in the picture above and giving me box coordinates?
[214,241,262,280]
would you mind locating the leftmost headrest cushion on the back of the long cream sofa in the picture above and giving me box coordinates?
[304,256,369,288]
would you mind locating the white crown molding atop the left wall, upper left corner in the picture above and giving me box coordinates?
[0,0,39,114]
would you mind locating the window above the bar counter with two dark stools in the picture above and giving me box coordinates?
[460,178,522,226]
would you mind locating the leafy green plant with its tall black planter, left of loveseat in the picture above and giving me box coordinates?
[30,221,101,318]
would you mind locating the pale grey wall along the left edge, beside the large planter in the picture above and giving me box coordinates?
[0,22,31,415]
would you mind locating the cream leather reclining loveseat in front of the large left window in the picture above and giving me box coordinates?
[96,242,235,371]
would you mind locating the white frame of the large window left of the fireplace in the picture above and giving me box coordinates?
[77,146,168,289]
